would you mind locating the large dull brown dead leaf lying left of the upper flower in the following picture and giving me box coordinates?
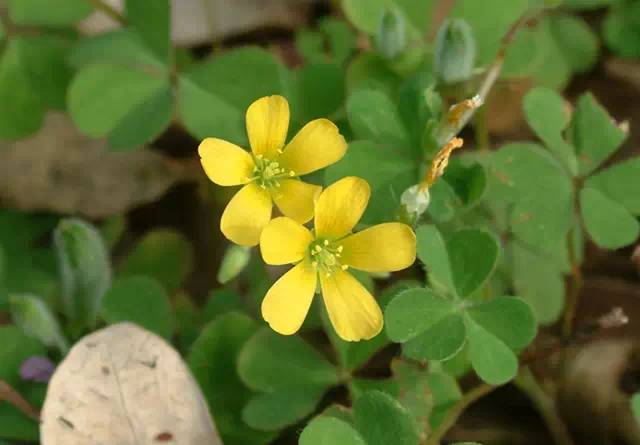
[0,113,190,218]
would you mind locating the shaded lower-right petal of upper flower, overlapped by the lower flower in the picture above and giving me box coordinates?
[272,179,322,224]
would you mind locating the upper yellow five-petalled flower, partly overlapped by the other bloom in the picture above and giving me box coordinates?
[198,96,347,246]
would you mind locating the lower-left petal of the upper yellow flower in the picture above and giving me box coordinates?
[220,182,271,246]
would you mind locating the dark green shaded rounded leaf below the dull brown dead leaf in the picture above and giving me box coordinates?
[118,229,194,292]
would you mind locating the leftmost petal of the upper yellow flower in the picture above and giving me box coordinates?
[198,138,254,185]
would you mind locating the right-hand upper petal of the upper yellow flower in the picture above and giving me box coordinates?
[280,119,347,175]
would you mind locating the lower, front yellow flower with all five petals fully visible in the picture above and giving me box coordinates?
[260,177,416,341]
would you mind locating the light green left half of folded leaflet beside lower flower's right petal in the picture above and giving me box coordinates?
[416,224,455,291]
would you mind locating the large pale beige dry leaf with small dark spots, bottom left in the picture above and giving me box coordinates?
[40,323,222,445]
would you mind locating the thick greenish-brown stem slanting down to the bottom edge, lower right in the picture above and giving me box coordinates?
[514,366,574,445]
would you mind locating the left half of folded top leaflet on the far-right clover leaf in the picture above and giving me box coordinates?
[524,87,578,176]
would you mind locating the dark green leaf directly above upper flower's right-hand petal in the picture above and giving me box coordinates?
[296,62,345,122]
